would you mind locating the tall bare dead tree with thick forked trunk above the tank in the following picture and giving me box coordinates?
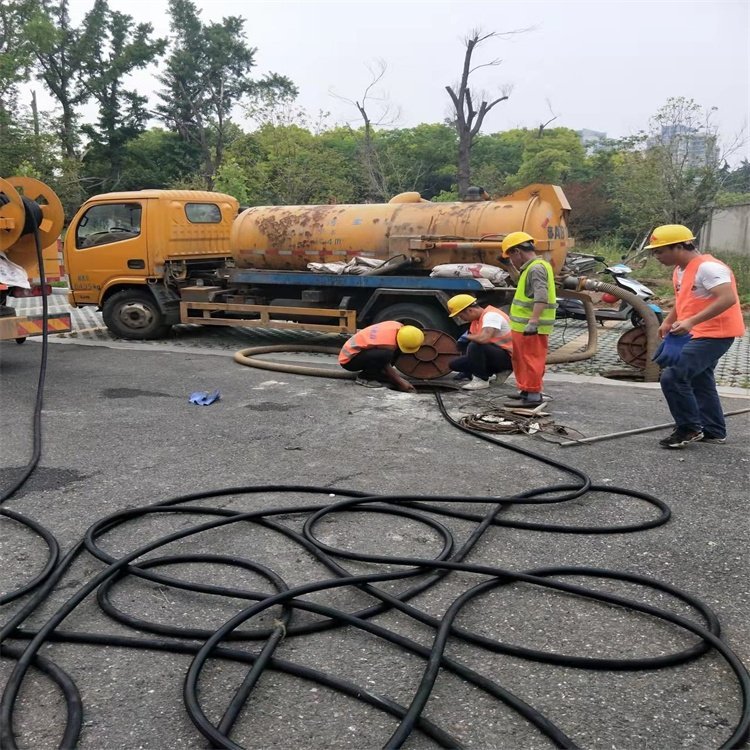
[445,29,529,195]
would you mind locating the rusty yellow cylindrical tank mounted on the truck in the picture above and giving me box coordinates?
[230,185,573,271]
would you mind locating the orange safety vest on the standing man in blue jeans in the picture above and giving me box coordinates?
[672,254,745,339]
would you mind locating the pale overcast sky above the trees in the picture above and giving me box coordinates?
[42,0,750,163]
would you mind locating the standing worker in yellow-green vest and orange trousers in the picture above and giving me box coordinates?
[501,232,557,408]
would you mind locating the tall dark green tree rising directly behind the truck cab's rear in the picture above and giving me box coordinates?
[157,0,296,187]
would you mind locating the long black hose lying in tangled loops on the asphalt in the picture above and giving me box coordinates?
[0,352,750,750]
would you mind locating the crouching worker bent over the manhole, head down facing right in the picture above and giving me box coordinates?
[339,320,424,393]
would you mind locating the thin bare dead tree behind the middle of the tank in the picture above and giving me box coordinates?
[328,59,401,200]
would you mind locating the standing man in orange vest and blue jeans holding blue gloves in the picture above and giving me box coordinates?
[646,224,745,448]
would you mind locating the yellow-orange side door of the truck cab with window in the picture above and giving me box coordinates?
[65,200,149,304]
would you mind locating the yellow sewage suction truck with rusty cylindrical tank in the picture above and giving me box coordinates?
[64,185,573,339]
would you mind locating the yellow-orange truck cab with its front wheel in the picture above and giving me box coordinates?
[64,190,239,339]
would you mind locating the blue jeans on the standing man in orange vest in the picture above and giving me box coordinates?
[660,338,734,437]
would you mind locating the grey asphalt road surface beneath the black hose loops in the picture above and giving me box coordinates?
[0,341,750,750]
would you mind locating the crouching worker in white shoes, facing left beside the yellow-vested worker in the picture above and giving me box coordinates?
[448,294,513,391]
